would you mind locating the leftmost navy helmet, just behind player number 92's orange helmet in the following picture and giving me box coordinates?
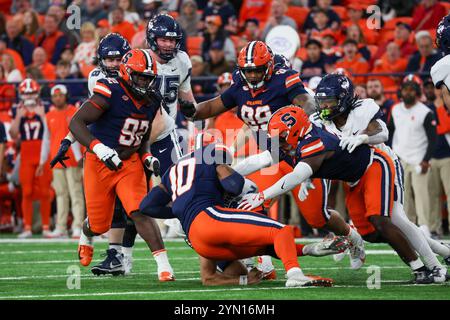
[97,33,131,78]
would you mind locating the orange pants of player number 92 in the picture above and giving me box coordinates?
[84,152,147,234]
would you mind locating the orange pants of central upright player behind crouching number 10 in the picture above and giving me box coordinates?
[247,161,330,228]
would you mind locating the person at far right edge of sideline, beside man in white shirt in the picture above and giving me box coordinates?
[424,82,450,236]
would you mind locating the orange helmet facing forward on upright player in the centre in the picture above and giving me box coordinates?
[238,41,274,90]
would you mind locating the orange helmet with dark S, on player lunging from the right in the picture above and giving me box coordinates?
[267,105,312,155]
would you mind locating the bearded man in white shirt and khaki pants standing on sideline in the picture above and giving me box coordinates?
[388,74,437,236]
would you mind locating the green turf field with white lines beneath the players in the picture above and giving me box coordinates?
[0,237,450,300]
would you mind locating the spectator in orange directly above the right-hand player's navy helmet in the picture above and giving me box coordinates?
[335,39,369,84]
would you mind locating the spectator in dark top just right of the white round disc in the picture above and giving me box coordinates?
[301,39,329,77]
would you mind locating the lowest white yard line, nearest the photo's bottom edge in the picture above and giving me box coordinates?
[0,284,446,300]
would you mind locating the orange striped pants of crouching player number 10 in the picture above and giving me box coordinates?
[189,206,303,271]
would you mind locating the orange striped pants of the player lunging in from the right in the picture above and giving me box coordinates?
[344,149,395,236]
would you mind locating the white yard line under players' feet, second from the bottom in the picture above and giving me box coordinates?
[0,265,409,281]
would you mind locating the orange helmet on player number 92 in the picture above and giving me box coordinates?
[119,49,158,97]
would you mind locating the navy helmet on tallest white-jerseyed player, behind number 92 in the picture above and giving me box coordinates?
[147,14,183,61]
